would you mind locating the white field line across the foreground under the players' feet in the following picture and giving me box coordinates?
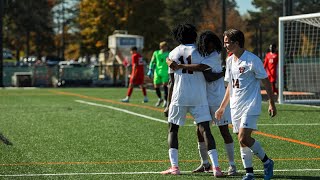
[0,169,320,177]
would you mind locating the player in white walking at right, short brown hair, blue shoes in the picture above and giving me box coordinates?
[215,29,277,180]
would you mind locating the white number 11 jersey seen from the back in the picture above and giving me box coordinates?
[169,44,208,106]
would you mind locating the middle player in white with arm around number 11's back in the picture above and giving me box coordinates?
[167,31,237,175]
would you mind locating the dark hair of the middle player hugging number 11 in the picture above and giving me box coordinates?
[198,31,222,56]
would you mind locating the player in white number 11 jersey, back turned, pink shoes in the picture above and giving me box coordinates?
[161,24,223,177]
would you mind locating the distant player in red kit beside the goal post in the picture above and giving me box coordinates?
[263,44,279,94]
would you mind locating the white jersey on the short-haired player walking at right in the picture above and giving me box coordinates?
[225,51,268,119]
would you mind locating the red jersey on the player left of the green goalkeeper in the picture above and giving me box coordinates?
[130,53,144,85]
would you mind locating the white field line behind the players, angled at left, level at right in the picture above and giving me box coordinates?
[75,100,320,127]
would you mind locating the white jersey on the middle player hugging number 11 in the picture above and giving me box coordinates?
[201,51,226,106]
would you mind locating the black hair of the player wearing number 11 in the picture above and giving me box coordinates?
[172,23,197,44]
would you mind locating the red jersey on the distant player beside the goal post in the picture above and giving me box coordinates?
[263,52,278,82]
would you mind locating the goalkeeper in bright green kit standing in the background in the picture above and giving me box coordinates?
[148,41,169,107]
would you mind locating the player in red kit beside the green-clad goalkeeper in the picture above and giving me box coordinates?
[121,46,149,103]
